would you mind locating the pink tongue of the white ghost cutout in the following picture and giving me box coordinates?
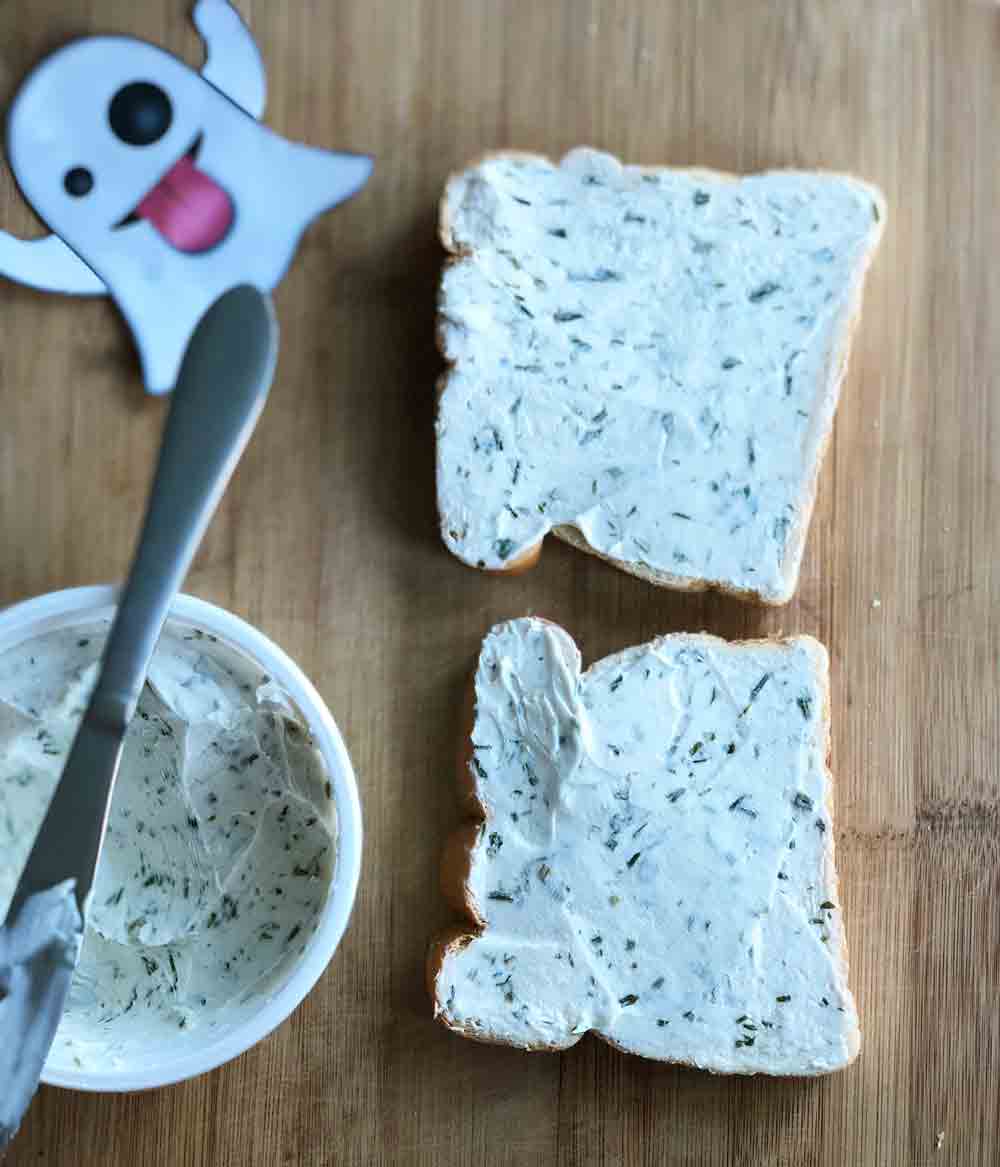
[135,155,233,252]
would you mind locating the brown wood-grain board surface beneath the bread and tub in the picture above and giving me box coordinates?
[0,0,1000,1167]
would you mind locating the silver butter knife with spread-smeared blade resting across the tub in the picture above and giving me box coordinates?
[0,286,278,1149]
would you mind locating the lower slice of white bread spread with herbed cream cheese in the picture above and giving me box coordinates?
[427,619,860,1075]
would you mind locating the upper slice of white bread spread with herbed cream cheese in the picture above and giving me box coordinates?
[438,149,886,603]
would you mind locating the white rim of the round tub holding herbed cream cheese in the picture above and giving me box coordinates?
[0,587,362,1091]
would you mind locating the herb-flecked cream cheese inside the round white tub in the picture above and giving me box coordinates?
[0,589,357,1089]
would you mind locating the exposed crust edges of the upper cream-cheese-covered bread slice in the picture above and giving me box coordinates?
[436,146,886,608]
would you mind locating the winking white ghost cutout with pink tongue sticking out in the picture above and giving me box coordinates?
[0,0,372,393]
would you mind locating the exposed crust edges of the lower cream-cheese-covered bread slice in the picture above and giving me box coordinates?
[425,617,860,1077]
